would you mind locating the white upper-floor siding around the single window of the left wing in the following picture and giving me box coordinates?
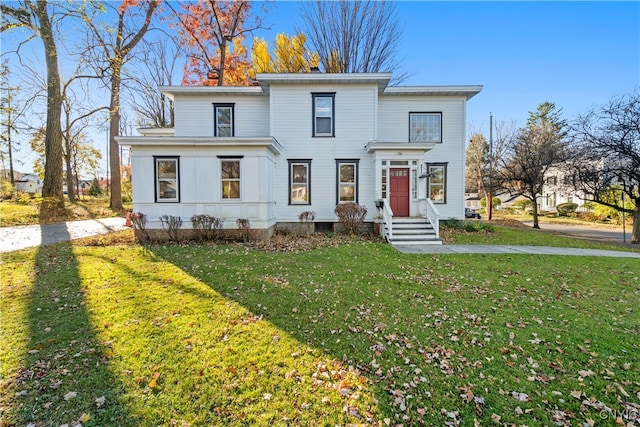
[175,95,269,137]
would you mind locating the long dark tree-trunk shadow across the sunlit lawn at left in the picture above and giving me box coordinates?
[8,236,137,426]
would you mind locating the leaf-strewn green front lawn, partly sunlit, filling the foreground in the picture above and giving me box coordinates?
[0,240,640,426]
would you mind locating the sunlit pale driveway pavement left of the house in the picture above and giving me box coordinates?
[0,217,127,253]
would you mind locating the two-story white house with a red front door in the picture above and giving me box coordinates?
[117,72,482,242]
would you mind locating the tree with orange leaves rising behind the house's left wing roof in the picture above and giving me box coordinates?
[167,0,262,86]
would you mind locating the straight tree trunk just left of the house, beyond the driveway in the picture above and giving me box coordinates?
[109,73,122,209]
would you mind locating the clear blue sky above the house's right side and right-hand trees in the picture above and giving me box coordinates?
[260,1,640,134]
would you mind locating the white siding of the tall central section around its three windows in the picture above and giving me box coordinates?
[270,85,377,222]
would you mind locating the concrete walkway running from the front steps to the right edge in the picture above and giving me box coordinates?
[393,245,640,258]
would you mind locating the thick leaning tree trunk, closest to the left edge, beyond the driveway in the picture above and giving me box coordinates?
[36,0,64,209]
